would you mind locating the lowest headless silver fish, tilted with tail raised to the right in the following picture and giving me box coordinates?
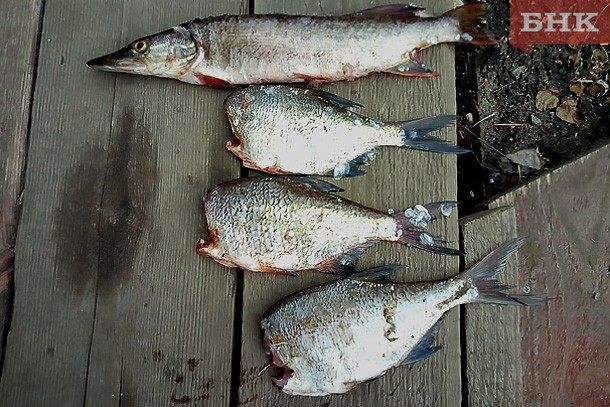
[261,239,548,396]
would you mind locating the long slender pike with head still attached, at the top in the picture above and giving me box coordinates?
[88,3,495,86]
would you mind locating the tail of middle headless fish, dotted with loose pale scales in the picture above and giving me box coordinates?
[392,201,464,256]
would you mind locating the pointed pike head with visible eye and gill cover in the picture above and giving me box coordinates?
[87,26,199,79]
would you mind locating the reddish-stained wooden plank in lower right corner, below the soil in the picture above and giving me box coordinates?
[490,144,610,406]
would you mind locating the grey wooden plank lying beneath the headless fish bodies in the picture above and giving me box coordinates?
[239,0,461,406]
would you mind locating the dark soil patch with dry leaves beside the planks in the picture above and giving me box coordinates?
[456,0,610,214]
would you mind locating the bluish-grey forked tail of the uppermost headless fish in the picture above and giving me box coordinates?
[396,115,470,154]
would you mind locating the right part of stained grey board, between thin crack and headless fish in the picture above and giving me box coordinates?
[82,0,243,406]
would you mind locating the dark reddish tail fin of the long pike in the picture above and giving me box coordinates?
[442,2,497,45]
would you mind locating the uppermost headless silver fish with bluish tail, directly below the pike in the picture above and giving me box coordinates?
[224,85,468,179]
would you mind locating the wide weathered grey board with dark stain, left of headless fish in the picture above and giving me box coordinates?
[0,0,247,406]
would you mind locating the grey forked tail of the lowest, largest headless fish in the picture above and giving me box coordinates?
[458,238,551,305]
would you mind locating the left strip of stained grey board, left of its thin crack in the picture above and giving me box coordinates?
[0,0,120,406]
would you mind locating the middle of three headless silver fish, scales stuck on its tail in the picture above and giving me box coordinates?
[197,176,461,274]
